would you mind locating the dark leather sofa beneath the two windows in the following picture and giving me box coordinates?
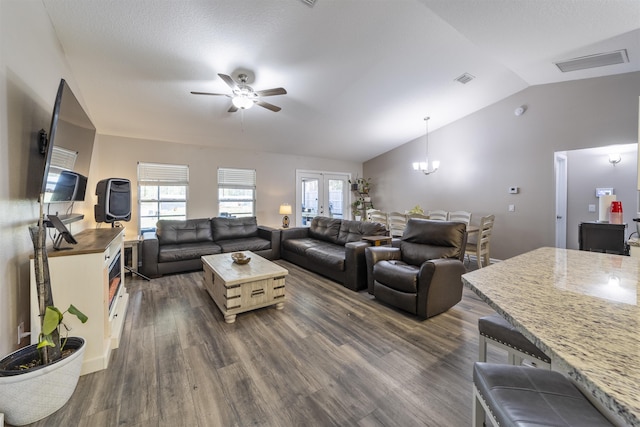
[140,217,280,277]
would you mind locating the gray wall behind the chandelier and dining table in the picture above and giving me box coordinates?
[363,72,640,259]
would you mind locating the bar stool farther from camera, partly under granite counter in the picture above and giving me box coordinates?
[478,314,551,369]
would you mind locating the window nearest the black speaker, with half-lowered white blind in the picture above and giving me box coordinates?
[138,163,189,233]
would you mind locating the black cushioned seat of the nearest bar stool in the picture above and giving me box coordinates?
[473,362,613,427]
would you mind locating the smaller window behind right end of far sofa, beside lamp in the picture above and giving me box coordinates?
[218,168,256,218]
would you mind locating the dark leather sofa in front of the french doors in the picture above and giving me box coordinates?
[280,216,387,291]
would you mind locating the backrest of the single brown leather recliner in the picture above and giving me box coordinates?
[400,219,467,265]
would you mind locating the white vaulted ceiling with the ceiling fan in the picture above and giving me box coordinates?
[42,0,640,162]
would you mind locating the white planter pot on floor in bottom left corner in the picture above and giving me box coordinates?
[0,337,86,426]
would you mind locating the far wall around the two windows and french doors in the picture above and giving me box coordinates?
[89,135,362,235]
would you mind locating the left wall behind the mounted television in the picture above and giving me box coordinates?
[0,0,89,355]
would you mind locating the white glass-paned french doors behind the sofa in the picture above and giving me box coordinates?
[296,170,349,227]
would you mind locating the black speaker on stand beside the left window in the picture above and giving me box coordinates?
[94,178,131,222]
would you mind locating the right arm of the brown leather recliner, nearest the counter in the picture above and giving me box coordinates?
[416,258,466,319]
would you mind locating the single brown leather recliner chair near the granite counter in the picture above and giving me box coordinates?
[365,219,467,319]
